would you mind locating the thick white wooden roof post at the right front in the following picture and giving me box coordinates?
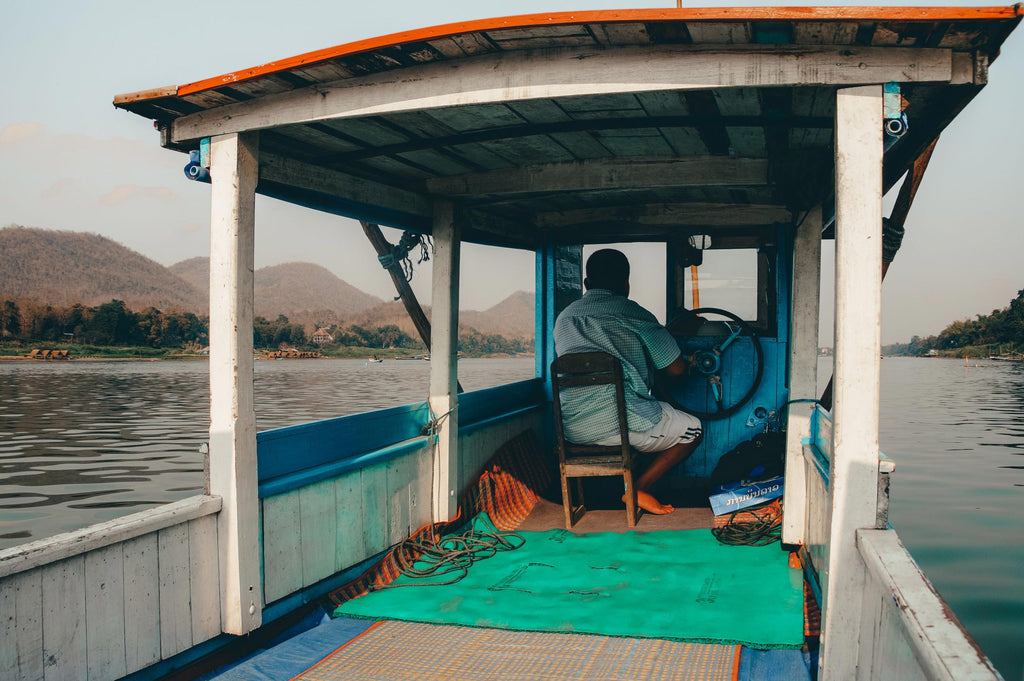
[819,85,883,681]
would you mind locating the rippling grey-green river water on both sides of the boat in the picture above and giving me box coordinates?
[0,358,1024,681]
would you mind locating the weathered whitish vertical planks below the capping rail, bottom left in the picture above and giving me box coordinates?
[0,513,220,681]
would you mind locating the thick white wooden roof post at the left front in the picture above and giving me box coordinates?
[209,133,263,634]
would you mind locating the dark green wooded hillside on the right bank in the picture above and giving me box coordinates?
[882,289,1024,355]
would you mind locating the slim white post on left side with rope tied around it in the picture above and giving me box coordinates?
[429,201,461,522]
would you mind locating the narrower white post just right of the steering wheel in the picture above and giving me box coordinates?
[782,201,821,544]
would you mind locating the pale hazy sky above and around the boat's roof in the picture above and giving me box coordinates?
[0,0,1024,344]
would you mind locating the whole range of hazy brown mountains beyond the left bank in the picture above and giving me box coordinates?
[0,226,534,338]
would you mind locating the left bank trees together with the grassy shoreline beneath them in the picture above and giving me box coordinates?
[0,300,534,361]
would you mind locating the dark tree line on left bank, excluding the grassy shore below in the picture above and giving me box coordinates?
[0,300,532,354]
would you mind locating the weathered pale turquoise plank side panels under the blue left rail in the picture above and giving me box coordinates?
[261,410,544,603]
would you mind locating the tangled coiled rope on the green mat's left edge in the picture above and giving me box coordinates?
[370,527,526,591]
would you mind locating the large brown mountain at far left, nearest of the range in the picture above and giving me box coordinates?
[0,226,208,312]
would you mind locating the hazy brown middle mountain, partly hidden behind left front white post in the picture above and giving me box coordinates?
[169,257,384,325]
